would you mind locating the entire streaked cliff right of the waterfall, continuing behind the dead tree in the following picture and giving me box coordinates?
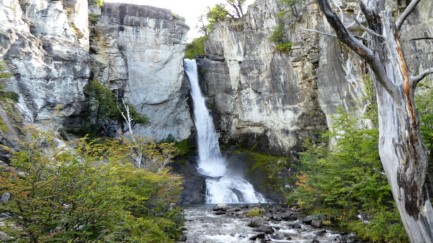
[201,0,433,153]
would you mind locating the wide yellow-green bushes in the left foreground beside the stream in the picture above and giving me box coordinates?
[0,128,183,242]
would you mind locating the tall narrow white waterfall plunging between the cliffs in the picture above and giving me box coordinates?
[184,59,266,203]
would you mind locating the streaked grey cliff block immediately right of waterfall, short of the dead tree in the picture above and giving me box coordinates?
[202,0,326,153]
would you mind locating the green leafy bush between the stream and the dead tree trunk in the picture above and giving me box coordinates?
[289,109,407,242]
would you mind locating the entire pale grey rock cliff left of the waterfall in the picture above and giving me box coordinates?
[0,0,193,161]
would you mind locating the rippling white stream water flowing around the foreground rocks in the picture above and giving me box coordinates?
[182,204,361,243]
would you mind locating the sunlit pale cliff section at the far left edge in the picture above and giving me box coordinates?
[0,0,90,129]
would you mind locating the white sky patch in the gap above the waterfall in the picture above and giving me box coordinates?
[105,0,254,39]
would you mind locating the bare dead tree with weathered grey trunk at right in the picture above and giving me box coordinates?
[316,0,433,242]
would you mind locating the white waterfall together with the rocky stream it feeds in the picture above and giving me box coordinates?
[179,59,357,243]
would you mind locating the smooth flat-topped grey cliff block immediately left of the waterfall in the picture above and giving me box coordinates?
[91,3,193,140]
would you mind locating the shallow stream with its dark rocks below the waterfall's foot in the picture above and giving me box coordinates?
[181,204,361,243]
